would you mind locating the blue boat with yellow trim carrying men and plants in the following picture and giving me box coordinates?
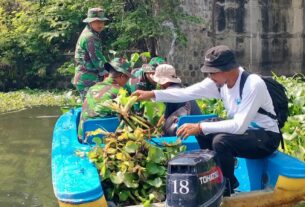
[52,108,305,207]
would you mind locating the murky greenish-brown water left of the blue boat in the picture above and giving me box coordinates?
[0,107,60,207]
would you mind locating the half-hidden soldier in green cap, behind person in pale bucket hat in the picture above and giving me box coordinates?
[126,57,165,93]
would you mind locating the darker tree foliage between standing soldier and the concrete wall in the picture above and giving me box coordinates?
[103,0,199,53]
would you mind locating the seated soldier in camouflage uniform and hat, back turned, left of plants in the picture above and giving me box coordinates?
[78,58,132,140]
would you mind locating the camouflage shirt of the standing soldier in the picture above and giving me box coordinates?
[73,26,107,91]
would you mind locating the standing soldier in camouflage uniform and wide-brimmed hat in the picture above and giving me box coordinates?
[73,8,108,100]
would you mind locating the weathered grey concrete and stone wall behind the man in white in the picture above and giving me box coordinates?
[159,0,305,84]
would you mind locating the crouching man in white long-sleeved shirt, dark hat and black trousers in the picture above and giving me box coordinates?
[134,45,281,194]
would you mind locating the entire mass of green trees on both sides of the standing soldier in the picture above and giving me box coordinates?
[0,0,201,90]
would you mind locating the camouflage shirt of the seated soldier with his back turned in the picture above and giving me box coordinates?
[78,77,121,139]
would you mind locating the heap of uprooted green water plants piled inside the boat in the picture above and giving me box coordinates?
[87,90,186,206]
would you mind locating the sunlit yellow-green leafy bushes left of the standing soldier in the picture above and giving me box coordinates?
[0,0,94,88]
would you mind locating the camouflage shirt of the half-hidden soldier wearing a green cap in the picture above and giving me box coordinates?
[125,68,156,93]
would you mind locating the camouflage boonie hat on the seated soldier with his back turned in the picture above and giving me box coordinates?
[104,58,134,78]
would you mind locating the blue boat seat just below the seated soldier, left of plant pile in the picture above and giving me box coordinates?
[83,117,120,144]
